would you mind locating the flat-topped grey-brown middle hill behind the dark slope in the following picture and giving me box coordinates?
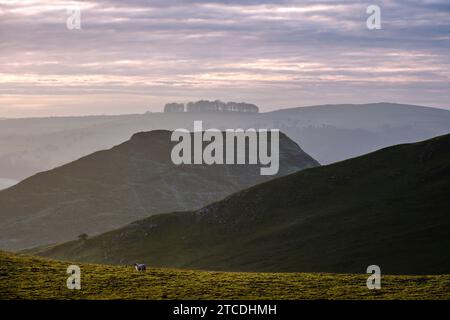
[0,131,319,250]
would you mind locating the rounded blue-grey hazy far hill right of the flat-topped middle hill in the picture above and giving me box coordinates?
[263,103,450,164]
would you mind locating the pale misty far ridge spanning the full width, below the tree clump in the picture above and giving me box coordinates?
[0,103,450,180]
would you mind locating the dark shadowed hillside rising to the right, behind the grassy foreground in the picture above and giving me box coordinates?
[34,135,450,274]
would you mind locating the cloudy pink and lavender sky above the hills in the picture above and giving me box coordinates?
[0,0,450,117]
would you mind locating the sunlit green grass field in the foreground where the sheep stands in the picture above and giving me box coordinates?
[0,252,450,299]
